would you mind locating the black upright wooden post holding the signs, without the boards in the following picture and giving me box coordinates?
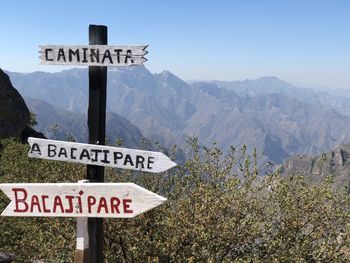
[87,25,107,263]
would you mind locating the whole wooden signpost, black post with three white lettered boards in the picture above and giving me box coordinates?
[0,25,176,263]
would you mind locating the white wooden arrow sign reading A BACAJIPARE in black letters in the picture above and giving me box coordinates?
[28,137,177,173]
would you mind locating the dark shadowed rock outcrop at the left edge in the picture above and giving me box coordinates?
[0,69,30,138]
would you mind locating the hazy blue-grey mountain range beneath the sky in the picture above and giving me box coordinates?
[8,66,350,163]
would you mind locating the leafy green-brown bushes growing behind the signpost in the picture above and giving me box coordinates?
[0,139,350,262]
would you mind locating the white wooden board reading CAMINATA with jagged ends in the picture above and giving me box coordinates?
[39,45,148,66]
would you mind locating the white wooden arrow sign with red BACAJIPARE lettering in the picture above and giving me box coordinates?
[0,183,166,218]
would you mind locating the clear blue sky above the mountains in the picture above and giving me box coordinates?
[0,0,350,89]
